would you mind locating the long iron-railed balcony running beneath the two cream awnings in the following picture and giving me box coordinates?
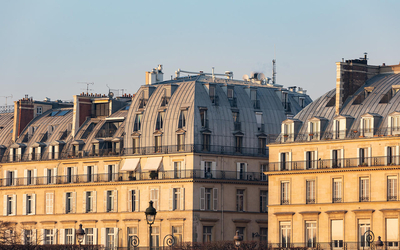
[0,170,265,187]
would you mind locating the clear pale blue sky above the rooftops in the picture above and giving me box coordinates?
[0,0,400,105]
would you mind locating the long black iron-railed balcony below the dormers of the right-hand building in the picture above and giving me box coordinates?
[267,156,400,172]
